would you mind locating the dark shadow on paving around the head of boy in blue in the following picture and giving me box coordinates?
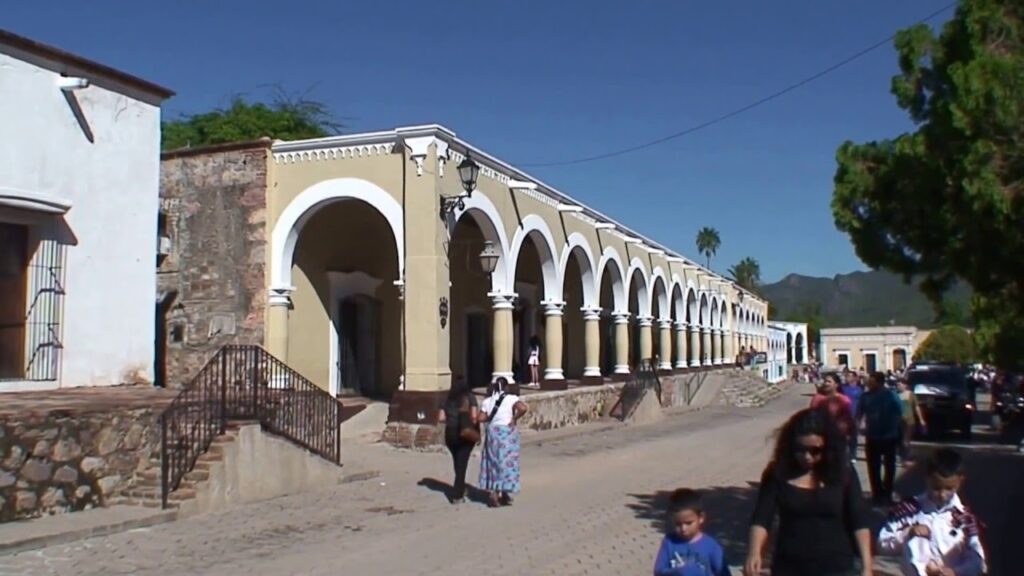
[627,482,759,565]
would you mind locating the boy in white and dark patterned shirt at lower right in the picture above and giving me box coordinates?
[879,448,987,576]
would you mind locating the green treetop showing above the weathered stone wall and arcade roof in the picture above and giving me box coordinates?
[161,95,341,150]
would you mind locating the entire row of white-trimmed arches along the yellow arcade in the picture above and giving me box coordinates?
[268,178,766,396]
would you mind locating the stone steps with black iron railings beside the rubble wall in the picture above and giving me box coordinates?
[108,421,243,510]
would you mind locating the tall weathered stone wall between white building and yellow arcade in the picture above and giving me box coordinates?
[157,139,270,387]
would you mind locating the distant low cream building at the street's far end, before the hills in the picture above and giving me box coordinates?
[819,326,931,372]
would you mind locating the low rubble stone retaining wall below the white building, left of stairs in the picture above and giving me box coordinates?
[0,399,163,522]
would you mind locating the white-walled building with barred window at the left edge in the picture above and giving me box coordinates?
[0,30,172,392]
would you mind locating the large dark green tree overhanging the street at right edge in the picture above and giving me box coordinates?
[833,0,1024,368]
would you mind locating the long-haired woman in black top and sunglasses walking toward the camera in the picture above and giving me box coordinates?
[743,408,872,576]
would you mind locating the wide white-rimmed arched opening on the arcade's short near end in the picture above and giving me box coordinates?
[286,194,401,397]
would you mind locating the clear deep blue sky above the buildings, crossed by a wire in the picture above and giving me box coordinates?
[0,0,949,282]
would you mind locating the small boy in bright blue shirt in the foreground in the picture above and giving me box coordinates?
[654,488,732,576]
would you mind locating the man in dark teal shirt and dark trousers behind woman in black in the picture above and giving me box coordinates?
[857,372,903,506]
